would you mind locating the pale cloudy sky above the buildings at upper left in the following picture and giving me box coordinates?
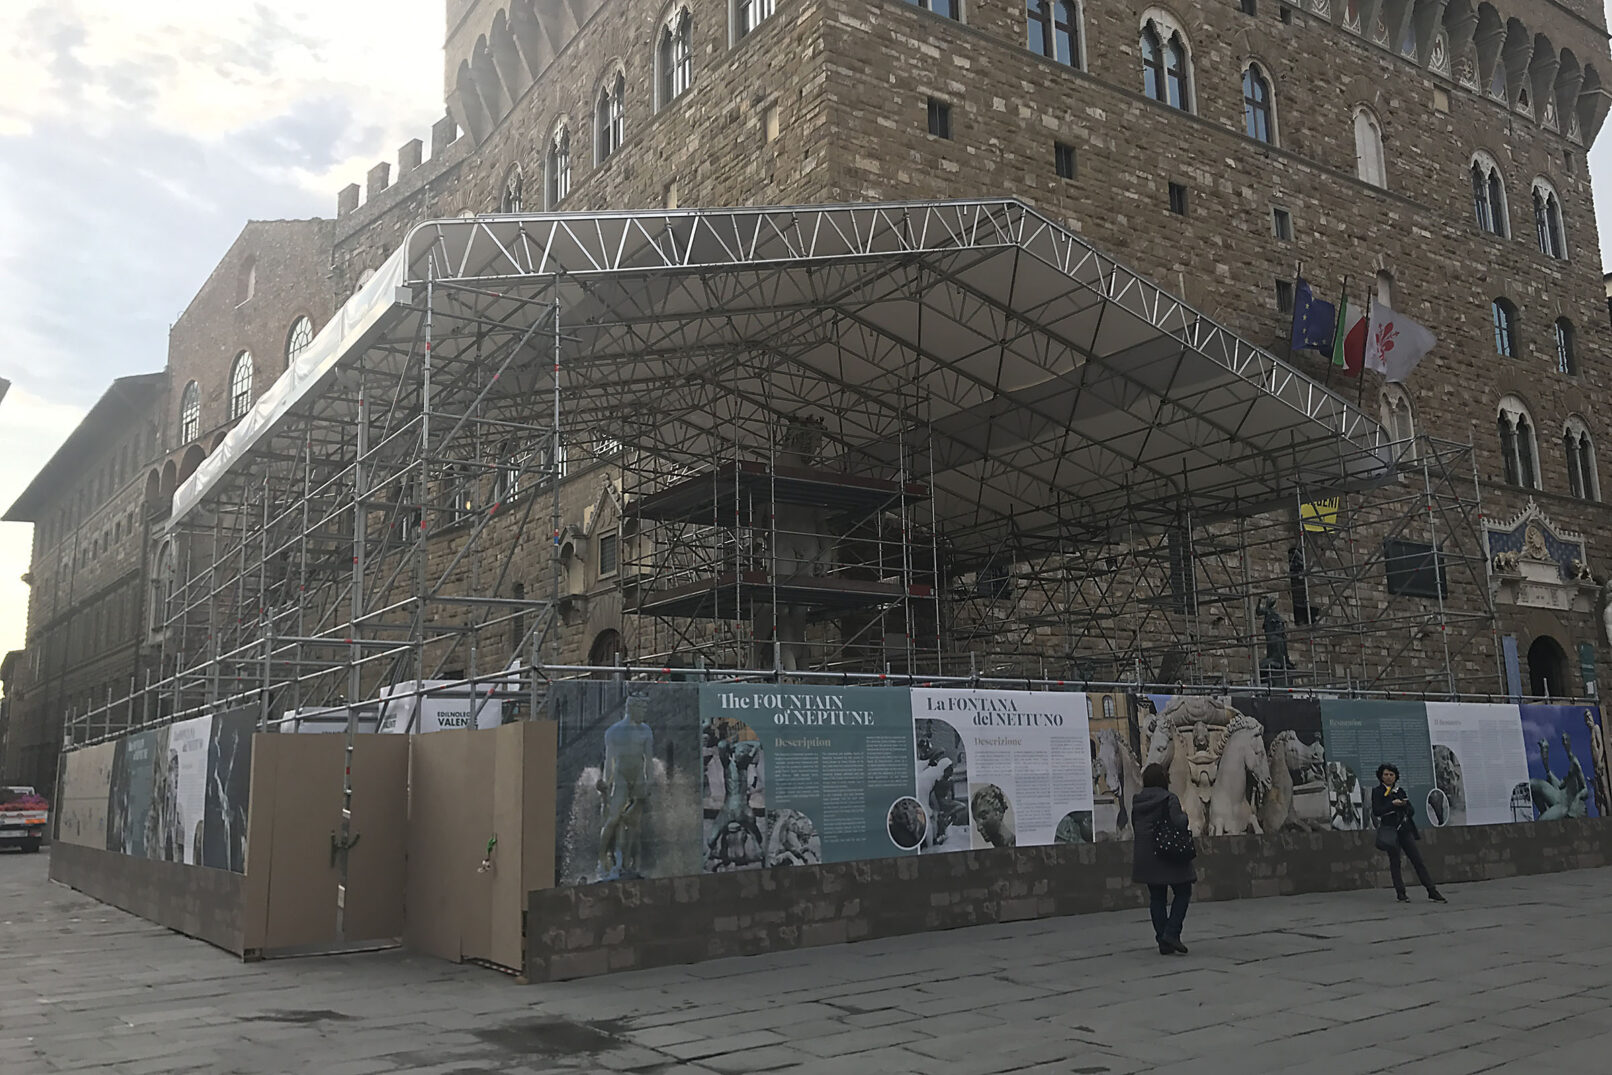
[0,0,1612,667]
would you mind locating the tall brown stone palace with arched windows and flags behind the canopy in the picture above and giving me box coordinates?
[8,0,1612,786]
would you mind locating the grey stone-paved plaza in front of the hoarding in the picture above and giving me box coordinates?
[0,854,1612,1075]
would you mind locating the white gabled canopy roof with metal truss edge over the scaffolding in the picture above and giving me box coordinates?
[172,200,1391,551]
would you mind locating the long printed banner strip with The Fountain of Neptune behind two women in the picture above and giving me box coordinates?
[541,682,1612,885]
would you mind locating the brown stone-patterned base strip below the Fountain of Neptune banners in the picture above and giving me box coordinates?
[526,819,1612,982]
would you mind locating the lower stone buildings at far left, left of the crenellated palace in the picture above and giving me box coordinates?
[0,221,334,790]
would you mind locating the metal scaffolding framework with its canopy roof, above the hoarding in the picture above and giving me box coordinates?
[69,200,1493,741]
